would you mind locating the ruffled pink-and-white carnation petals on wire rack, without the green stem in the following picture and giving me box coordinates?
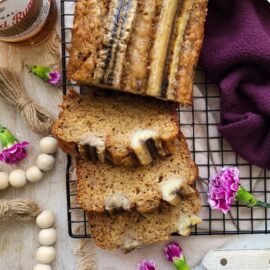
[208,167,240,214]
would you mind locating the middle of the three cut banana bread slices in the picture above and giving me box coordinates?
[77,135,198,213]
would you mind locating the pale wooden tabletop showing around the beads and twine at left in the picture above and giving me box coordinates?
[0,30,76,270]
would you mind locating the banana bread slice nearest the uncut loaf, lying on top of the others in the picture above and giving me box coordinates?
[52,90,179,166]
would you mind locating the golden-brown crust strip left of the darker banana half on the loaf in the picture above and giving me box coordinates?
[67,0,107,82]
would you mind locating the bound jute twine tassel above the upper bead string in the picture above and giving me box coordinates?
[0,68,52,135]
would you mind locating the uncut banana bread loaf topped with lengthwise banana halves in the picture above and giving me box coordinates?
[68,0,207,104]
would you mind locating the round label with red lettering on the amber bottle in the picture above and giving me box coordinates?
[0,0,51,42]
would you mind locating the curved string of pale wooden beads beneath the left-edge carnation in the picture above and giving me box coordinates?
[0,137,58,190]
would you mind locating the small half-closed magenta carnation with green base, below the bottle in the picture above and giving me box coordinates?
[27,65,62,86]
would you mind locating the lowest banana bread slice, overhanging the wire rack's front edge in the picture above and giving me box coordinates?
[88,192,201,252]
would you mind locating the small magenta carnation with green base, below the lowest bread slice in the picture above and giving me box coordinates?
[163,242,189,270]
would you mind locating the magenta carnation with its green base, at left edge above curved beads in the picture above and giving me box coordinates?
[0,126,29,164]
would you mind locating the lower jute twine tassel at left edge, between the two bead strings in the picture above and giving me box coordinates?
[0,199,41,222]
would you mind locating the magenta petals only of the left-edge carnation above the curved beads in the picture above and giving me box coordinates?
[0,142,29,164]
